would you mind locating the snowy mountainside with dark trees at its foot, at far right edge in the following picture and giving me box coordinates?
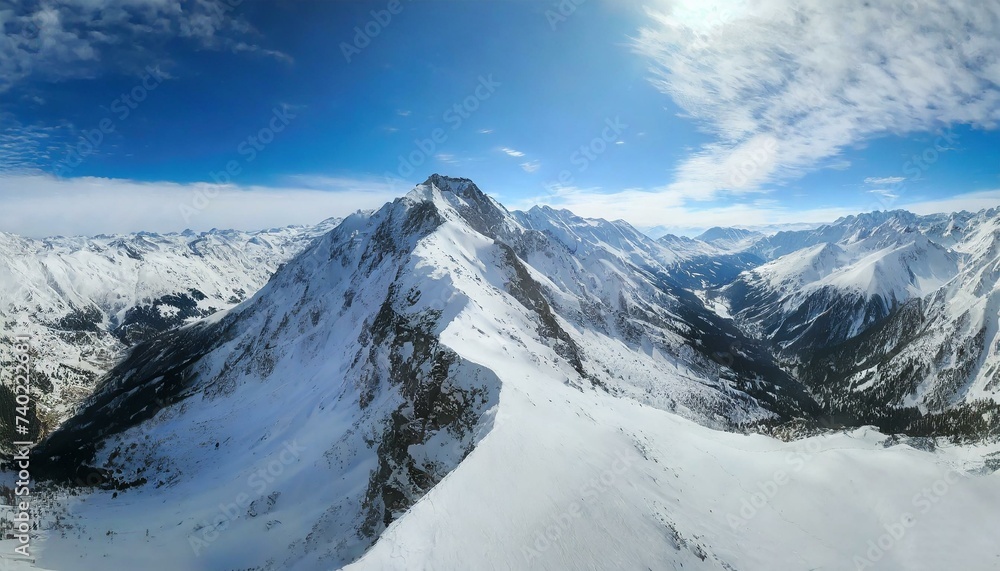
[801,211,1000,425]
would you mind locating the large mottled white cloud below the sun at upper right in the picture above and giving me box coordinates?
[634,0,1000,200]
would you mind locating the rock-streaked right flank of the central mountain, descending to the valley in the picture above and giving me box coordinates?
[496,194,813,426]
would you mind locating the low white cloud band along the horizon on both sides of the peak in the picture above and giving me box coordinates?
[0,175,1000,244]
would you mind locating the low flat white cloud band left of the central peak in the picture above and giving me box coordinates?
[0,175,398,237]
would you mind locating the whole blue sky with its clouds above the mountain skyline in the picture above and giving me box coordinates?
[0,0,1000,236]
